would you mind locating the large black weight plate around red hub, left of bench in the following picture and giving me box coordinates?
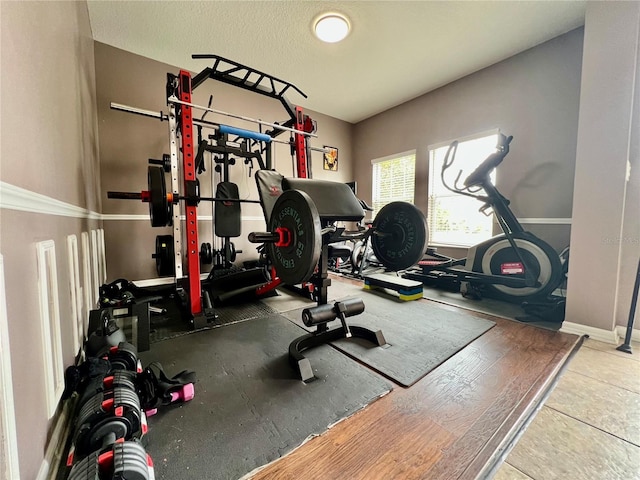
[268,190,322,285]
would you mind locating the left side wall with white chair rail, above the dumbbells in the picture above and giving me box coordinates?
[0,2,100,479]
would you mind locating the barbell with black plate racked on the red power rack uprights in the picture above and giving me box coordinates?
[107,165,260,227]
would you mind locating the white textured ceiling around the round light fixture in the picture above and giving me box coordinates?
[89,0,586,123]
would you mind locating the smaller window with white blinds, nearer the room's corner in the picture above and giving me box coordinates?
[371,150,416,217]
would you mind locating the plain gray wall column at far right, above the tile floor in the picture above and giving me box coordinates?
[566,2,640,330]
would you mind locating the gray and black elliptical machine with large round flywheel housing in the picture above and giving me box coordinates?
[403,134,563,303]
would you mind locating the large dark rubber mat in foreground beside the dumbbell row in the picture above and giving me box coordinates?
[141,314,392,480]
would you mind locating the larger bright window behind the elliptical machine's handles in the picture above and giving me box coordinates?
[428,130,499,247]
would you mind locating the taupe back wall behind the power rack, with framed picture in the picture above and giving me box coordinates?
[95,42,353,280]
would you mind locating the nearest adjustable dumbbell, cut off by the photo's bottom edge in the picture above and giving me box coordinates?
[67,441,155,480]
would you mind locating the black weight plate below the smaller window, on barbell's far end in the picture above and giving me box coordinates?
[371,202,429,271]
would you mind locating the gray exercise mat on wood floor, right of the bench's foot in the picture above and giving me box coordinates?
[283,290,495,387]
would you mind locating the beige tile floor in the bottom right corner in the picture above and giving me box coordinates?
[494,339,640,480]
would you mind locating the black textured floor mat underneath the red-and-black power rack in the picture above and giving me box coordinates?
[149,300,277,343]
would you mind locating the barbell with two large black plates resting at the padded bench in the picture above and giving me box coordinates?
[248,190,429,285]
